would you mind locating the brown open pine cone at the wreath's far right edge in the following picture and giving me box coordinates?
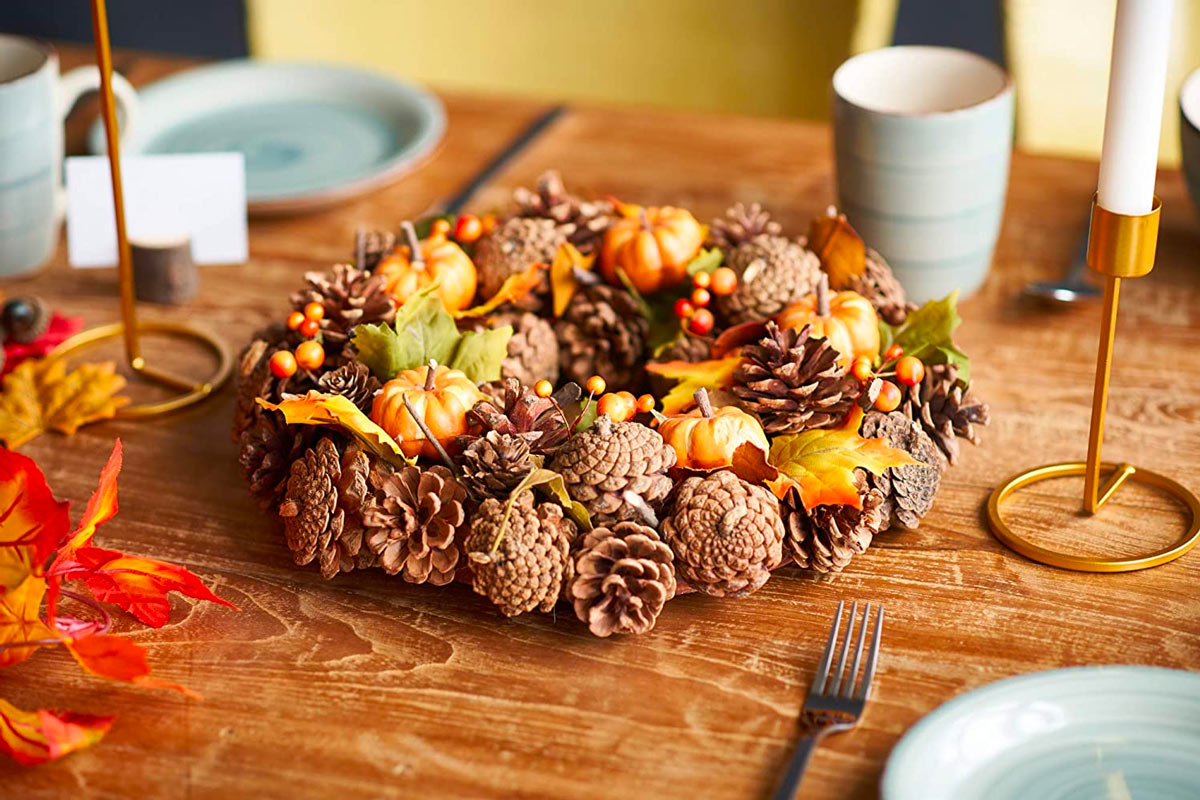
[900,363,991,465]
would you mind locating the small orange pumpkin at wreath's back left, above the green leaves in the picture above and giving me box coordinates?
[376,222,478,311]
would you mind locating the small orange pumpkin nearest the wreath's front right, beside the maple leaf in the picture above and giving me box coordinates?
[659,389,770,469]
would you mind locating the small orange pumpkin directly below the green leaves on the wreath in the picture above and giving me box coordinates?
[371,366,486,458]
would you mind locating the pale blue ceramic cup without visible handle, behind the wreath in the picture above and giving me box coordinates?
[833,47,1013,302]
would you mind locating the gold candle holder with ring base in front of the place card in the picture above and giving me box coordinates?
[48,0,233,419]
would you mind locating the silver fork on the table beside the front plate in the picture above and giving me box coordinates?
[774,601,883,800]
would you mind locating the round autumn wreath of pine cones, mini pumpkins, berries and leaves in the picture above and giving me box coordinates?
[234,174,988,636]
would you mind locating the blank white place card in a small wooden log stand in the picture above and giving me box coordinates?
[66,152,247,267]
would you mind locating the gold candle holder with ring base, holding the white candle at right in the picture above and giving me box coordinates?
[988,197,1200,572]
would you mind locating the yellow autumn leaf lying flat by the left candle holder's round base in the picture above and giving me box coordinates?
[0,359,130,447]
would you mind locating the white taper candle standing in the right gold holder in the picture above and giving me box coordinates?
[1097,0,1171,215]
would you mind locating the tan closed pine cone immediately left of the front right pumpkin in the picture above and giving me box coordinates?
[550,416,676,525]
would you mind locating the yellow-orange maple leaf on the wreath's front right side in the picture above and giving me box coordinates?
[768,407,919,509]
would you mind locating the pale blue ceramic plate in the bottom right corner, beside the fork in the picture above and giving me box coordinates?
[883,667,1200,800]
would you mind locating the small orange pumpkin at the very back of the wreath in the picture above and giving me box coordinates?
[600,205,708,294]
